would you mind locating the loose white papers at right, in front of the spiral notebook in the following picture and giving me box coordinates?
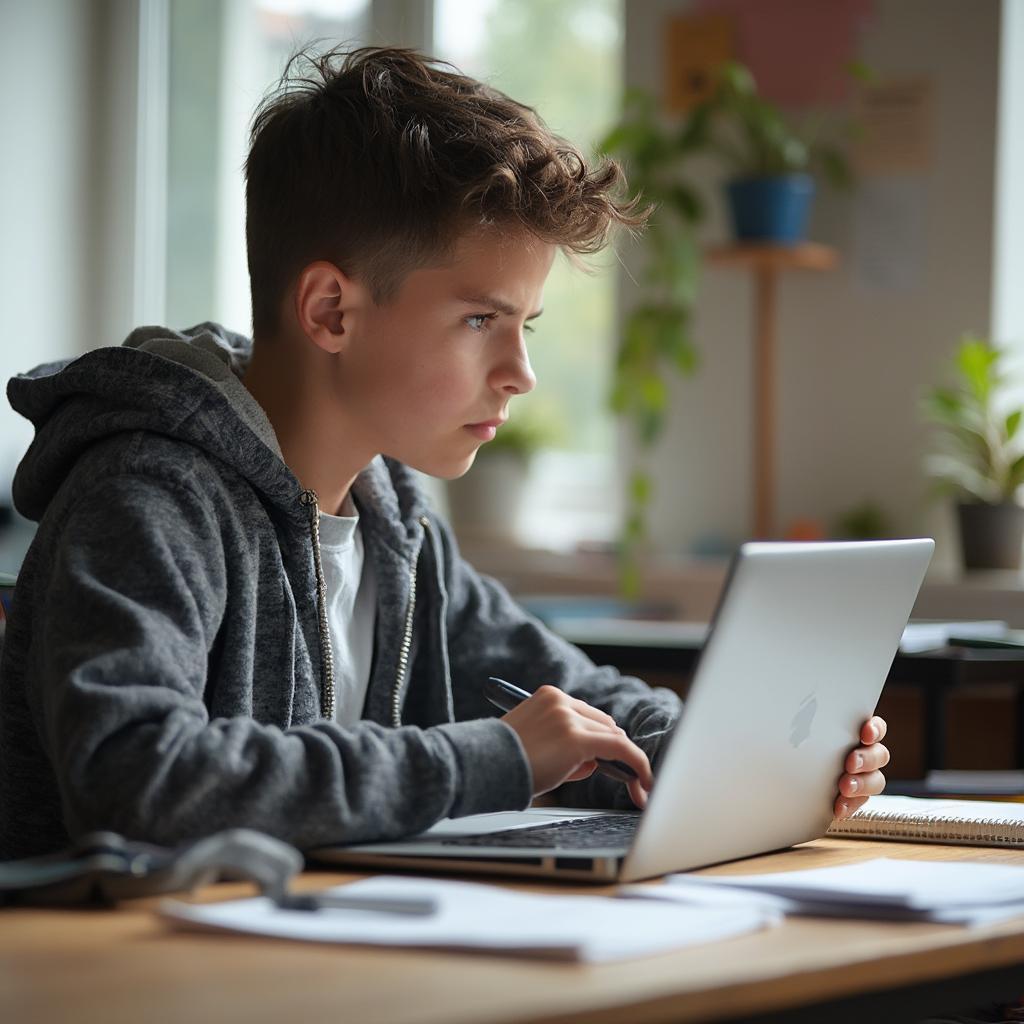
[623,857,1024,926]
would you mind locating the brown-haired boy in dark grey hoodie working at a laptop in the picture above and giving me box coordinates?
[0,49,888,857]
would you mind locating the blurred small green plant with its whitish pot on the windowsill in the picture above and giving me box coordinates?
[447,415,557,543]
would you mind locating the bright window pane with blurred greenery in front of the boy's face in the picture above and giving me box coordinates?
[433,0,625,548]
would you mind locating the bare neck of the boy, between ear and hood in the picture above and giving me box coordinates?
[242,337,373,515]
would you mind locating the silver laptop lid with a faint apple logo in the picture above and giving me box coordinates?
[622,540,935,881]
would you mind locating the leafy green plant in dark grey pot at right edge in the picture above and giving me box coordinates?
[923,335,1024,569]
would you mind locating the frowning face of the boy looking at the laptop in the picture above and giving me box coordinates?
[336,230,555,478]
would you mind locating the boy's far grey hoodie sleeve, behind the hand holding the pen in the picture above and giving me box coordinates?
[434,512,682,808]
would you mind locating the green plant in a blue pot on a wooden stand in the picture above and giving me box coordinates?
[691,62,865,244]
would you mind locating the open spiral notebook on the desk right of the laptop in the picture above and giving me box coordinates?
[827,797,1024,847]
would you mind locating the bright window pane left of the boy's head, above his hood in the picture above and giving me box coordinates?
[167,0,371,332]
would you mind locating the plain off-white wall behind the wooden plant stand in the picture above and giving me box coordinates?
[627,0,999,563]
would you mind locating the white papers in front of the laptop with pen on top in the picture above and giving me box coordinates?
[160,876,781,964]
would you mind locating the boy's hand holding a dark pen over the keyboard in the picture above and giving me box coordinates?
[504,686,654,807]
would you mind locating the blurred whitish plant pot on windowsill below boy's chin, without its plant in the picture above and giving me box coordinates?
[447,452,529,543]
